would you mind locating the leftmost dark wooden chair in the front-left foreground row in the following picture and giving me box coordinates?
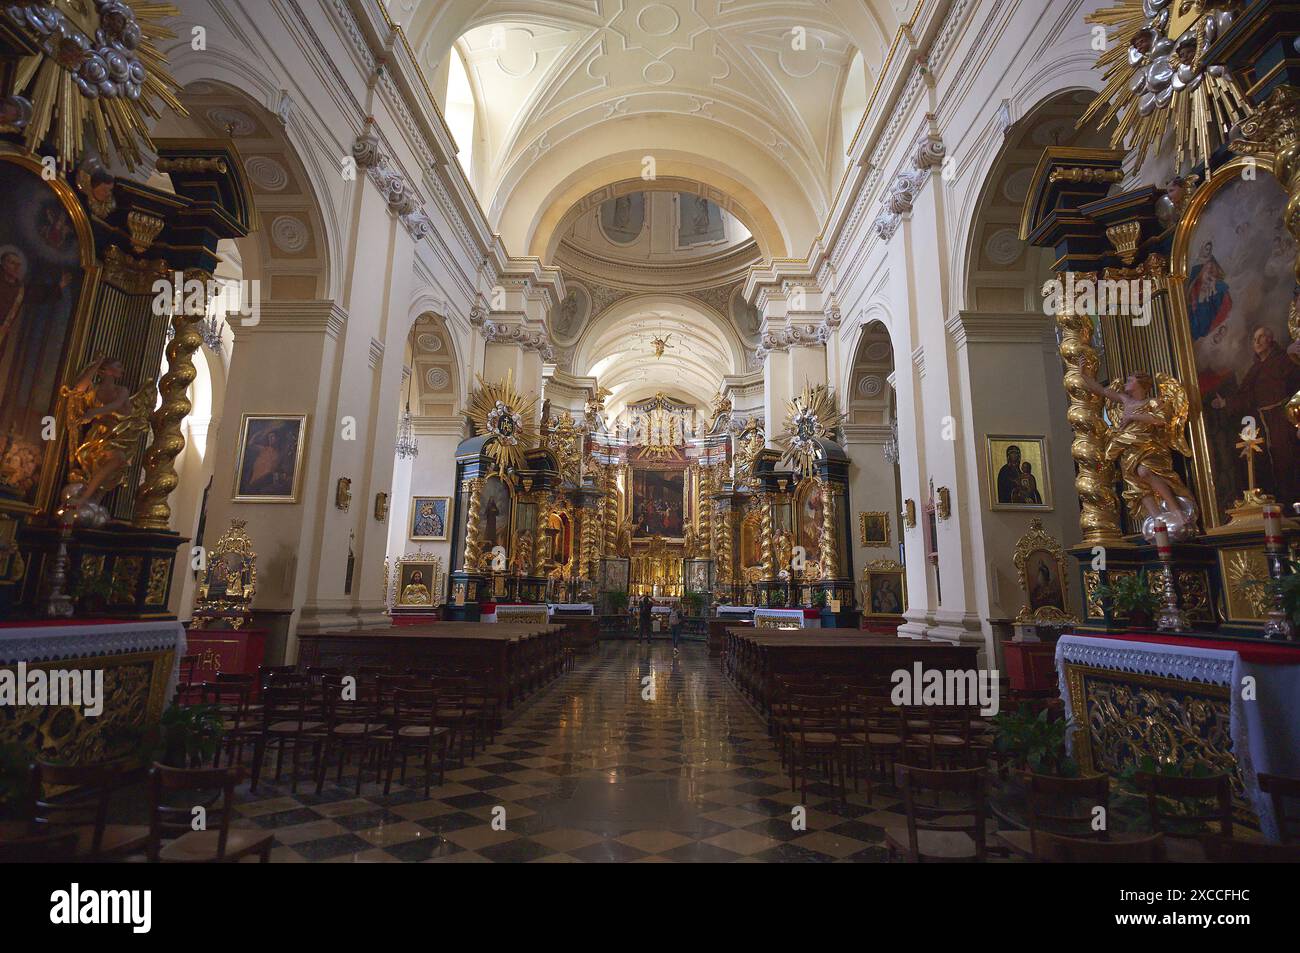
[30,761,150,861]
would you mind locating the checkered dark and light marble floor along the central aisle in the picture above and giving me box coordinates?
[228,642,930,863]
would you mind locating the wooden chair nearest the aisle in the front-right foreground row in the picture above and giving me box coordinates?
[885,764,988,863]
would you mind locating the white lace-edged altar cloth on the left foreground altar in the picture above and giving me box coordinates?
[0,620,186,701]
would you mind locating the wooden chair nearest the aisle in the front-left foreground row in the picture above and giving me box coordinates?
[148,764,276,863]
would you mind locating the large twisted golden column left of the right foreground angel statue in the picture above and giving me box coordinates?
[1043,273,1123,546]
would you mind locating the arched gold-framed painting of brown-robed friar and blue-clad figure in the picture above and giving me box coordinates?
[1174,166,1300,525]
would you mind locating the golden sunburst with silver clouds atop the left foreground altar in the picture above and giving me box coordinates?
[0,0,185,169]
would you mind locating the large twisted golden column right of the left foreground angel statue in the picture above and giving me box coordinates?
[134,269,212,529]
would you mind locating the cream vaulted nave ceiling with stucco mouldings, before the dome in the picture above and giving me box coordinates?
[390,0,913,254]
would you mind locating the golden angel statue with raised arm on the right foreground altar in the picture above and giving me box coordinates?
[1082,371,1196,540]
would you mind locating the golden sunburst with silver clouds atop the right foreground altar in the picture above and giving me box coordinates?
[1079,0,1251,172]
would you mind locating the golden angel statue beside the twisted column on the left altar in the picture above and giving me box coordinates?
[60,355,157,527]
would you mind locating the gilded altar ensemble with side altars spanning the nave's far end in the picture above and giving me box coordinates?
[449,381,854,618]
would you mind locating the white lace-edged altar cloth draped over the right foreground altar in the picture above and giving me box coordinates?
[1056,636,1300,840]
